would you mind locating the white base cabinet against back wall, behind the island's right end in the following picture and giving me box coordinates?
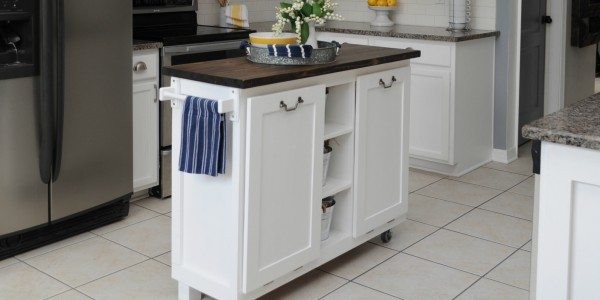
[319,32,494,176]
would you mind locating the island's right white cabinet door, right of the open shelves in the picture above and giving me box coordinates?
[354,67,410,237]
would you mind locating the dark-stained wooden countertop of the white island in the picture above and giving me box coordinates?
[163,44,421,89]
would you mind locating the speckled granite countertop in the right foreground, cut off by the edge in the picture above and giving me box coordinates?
[523,93,600,150]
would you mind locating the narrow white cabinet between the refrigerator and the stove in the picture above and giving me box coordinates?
[132,50,159,192]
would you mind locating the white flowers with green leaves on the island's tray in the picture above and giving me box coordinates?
[273,0,342,44]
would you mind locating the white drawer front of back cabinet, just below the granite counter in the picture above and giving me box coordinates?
[369,38,452,67]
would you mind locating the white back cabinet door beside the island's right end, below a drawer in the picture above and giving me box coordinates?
[410,64,453,164]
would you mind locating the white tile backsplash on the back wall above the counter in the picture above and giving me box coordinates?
[198,0,496,30]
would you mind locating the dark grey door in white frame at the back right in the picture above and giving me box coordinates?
[519,0,548,145]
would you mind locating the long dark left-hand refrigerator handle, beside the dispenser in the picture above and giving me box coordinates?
[38,1,56,184]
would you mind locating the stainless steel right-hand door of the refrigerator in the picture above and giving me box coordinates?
[51,0,133,221]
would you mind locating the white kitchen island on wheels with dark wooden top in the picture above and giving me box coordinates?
[160,44,420,299]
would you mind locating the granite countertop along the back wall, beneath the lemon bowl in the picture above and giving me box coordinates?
[251,21,500,42]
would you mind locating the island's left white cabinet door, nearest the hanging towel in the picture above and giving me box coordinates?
[244,85,325,292]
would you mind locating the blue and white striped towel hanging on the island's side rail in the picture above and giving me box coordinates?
[179,96,227,176]
